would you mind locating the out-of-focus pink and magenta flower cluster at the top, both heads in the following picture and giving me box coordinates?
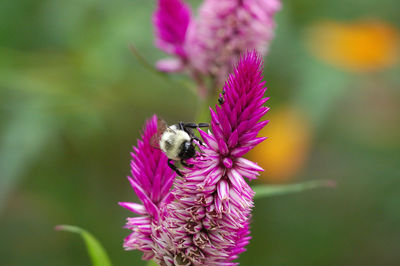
[155,0,281,84]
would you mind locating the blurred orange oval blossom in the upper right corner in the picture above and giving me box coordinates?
[306,20,400,72]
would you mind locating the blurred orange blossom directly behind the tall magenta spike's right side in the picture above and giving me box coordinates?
[248,107,311,183]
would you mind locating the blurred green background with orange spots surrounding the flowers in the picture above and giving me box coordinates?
[0,0,400,266]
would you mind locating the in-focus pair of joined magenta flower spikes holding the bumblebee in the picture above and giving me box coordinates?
[120,52,268,265]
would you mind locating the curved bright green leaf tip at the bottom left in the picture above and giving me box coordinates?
[55,225,111,266]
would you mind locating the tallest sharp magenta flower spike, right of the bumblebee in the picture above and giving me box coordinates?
[155,52,268,265]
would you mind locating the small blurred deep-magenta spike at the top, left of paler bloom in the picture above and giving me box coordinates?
[153,0,191,71]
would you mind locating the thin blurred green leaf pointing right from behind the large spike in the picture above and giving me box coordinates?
[253,180,336,199]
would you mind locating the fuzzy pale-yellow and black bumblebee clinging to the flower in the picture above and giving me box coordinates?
[151,119,209,176]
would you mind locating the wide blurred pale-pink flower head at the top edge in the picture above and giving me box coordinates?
[186,0,281,83]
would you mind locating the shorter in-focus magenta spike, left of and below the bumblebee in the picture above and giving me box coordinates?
[119,115,175,260]
